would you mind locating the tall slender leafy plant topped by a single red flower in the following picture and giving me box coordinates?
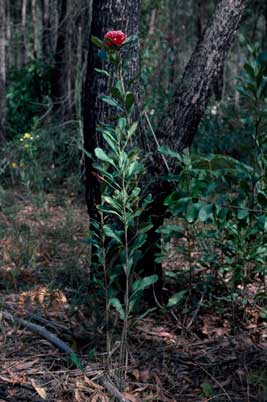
[89,31,157,380]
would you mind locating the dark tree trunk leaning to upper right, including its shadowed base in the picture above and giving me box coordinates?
[141,0,250,299]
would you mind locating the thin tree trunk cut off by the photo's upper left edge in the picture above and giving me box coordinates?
[0,0,6,144]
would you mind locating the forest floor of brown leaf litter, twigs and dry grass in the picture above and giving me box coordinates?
[0,189,267,402]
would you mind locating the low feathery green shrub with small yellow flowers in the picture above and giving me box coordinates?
[0,123,82,191]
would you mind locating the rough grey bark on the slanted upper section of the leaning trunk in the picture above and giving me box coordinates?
[157,0,248,160]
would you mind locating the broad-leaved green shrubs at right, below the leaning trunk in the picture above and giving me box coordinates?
[158,46,267,315]
